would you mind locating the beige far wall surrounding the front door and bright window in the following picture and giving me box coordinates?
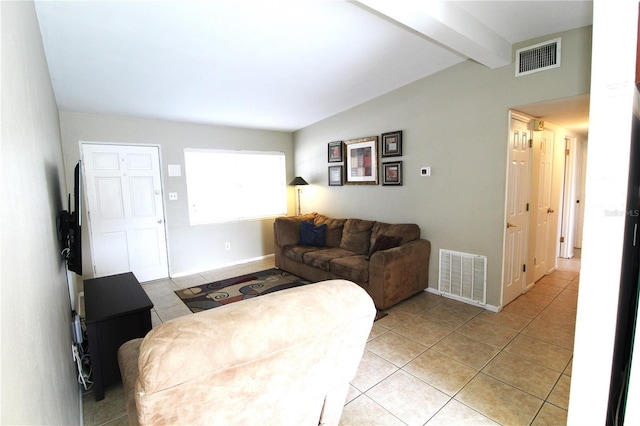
[60,112,294,277]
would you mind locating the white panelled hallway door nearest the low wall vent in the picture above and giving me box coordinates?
[502,113,531,306]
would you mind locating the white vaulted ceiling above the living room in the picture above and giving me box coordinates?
[36,0,592,131]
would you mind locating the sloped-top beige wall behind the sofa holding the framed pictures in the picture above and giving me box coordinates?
[294,27,591,306]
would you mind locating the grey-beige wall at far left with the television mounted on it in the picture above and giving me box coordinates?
[0,1,80,425]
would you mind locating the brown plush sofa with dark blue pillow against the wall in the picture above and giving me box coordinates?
[274,213,431,309]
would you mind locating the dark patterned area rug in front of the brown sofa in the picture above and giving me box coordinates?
[175,268,387,321]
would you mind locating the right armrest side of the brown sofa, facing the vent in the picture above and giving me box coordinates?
[368,239,431,309]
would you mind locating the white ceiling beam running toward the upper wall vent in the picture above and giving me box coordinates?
[357,0,511,68]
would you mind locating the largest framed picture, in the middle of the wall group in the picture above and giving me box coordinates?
[344,136,378,185]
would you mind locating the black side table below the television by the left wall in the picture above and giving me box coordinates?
[84,272,153,401]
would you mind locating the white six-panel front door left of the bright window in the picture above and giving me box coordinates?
[82,143,169,282]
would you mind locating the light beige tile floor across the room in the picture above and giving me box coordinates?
[83,252,580,426]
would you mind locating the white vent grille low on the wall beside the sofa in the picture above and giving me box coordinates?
[438,249,487,305]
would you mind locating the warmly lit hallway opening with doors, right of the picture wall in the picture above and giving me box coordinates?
[502,95,589,307]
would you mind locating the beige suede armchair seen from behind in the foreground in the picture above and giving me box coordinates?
[118,280,376,425]
